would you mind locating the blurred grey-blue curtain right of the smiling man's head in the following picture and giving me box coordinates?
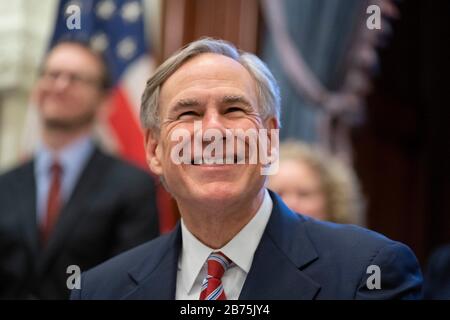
[260,0,366,143]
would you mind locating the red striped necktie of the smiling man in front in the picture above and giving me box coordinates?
[200,252,236,300]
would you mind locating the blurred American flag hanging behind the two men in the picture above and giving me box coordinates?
[44,0,176,233]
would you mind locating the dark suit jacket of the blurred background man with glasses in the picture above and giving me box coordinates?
[0,148,159,299]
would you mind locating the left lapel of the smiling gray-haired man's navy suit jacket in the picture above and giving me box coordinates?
[122,223,181,300]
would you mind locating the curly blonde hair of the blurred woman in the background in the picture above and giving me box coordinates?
[280,140,365,225]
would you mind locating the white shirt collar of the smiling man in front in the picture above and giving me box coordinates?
[178,189,273,292]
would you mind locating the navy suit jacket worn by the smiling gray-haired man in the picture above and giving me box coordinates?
[71,192,422,299]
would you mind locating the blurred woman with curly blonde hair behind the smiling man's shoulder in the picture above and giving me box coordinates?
[269,141,364,225]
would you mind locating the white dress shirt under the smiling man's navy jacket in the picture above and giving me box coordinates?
[175,189,273,300]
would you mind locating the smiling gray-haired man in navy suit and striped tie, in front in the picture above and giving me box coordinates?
[72,39,422,300]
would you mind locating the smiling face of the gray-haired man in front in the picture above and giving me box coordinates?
[146,53,276,205]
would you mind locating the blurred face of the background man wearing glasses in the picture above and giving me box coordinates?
[35,44,104,129]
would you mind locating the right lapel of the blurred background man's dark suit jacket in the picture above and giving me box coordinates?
[39,148,107,272]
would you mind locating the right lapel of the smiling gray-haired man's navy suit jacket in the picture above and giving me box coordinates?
[239,192,320,300]
